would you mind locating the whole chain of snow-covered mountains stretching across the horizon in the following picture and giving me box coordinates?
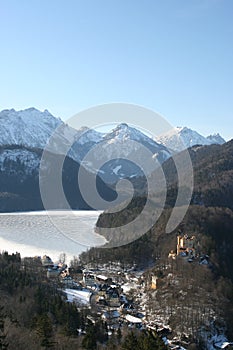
[0,108,225,183]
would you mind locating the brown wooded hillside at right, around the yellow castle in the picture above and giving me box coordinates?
[81,141,233,342]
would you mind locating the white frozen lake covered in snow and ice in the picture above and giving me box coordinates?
[0,211,105,262]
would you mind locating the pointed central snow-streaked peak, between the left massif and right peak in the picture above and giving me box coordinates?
[80,123,171,183]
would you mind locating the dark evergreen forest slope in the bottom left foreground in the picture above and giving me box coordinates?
[0,252,167,350]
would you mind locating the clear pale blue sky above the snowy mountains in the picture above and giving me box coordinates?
[0,0,233,139]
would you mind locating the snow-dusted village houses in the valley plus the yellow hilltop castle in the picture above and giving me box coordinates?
[30,235,232,350]
